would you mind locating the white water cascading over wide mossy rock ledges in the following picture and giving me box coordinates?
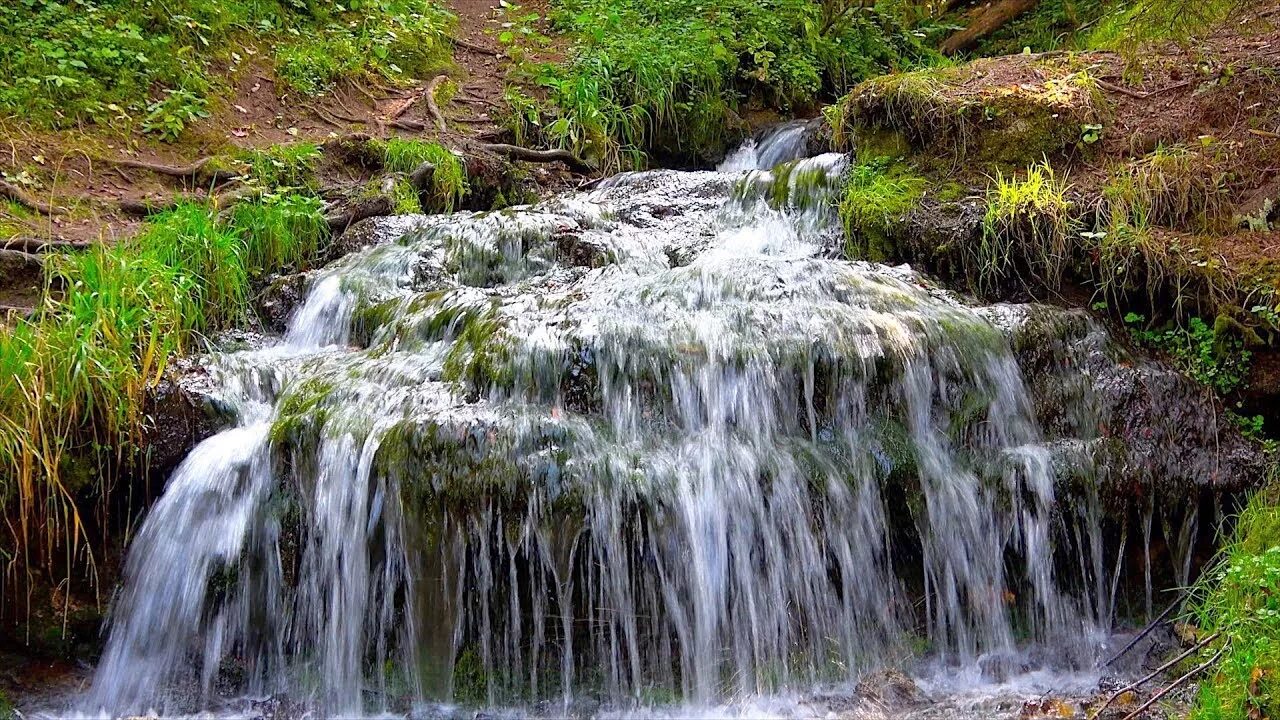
[72,133,1187,716]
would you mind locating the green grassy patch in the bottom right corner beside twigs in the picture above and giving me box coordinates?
[1190,473,1280,720]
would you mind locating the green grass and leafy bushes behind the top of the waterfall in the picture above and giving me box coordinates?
[507,0,929,168]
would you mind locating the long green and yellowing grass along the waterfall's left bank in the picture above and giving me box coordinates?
[0,197,326,604]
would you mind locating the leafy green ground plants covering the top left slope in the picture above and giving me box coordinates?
[0,0,452,140]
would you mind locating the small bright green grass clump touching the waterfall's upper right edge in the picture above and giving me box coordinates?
[840,158,924,261]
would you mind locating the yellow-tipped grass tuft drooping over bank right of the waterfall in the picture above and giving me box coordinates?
[972,161,1074,290]
